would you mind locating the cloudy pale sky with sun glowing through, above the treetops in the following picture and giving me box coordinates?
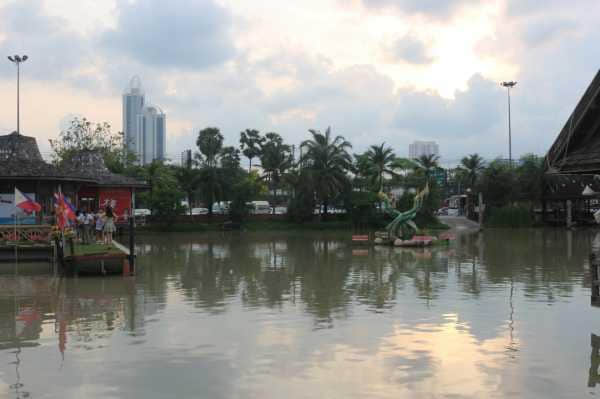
[0,0,600,164]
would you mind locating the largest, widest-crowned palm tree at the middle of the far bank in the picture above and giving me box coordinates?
[300,127,352,216]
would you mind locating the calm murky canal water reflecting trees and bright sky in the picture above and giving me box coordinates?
[0,229,600,399]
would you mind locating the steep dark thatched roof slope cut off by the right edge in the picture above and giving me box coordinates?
[546,71,600,174]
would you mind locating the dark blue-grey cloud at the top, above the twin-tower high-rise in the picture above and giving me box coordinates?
[101,0,235,68]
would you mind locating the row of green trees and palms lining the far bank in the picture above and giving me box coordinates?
[51,119,543,225]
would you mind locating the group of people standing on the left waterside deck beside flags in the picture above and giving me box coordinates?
[75,206,117,245]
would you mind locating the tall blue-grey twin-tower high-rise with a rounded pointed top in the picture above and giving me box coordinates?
[123,76,167,165]
